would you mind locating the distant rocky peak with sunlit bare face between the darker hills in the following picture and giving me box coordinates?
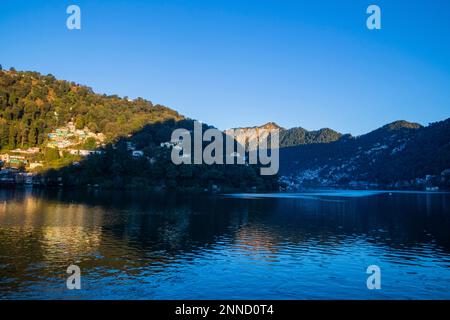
[225,122,342,148]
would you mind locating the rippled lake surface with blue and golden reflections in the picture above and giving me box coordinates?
[0,190,450,299]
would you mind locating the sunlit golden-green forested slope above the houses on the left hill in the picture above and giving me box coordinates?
[0,69,183,150]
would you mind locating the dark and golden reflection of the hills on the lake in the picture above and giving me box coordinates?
[0,191,450,296]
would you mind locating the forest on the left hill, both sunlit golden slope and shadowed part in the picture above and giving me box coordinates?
[0,69,278,191]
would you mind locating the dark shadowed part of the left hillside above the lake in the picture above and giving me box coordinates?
[33,119,278,192]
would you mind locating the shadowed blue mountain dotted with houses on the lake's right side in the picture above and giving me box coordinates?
[280,119,450,189]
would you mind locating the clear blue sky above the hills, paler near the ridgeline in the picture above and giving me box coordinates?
[0,0,450,134]
